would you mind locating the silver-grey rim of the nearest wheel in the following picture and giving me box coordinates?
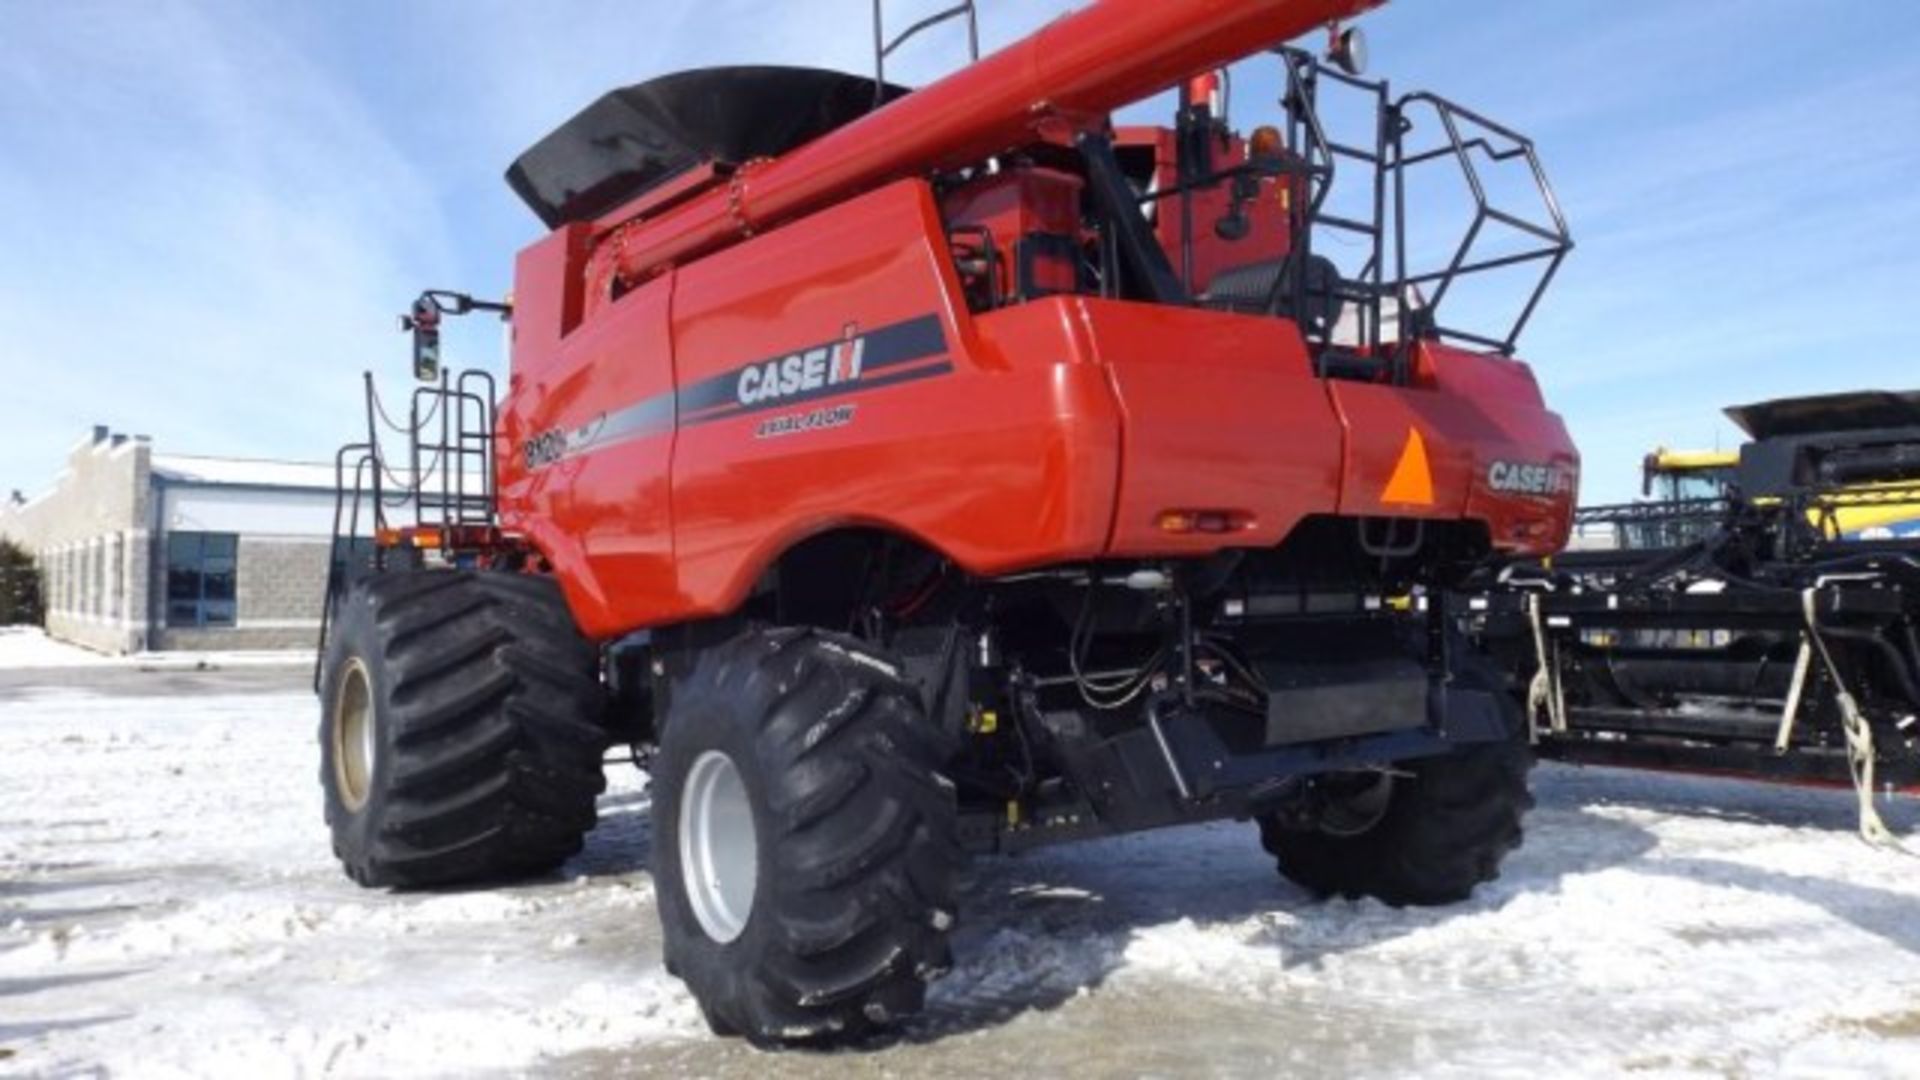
[680,749,760,945]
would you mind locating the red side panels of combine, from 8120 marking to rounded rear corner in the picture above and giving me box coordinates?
[501,181,1119,636]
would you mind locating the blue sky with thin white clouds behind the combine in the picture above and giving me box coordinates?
[0,0,1920,502]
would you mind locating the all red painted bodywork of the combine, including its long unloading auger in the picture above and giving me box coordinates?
[499,0,1576,638]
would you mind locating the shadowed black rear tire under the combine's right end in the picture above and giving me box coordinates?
[1260,668,1534,907]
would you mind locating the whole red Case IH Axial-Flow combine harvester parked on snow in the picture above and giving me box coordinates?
[317,0,1578,1042]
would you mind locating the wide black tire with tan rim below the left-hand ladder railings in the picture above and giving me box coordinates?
[321,571,607,888]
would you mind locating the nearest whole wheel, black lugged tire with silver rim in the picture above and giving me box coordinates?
[653,630,960,1043]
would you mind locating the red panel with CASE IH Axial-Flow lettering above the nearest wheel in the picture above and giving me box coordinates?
[660,181,1119,621]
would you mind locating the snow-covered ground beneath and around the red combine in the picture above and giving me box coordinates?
[0,671,1920,1078]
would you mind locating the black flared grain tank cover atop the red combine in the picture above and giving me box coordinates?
[507,67,906,229]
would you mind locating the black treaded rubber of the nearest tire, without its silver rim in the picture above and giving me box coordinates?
[653,626,962,1043]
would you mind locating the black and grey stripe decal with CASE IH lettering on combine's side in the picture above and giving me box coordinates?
[526,315,952,469]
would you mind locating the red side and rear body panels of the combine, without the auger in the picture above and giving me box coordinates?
[501,171,1574,636]
